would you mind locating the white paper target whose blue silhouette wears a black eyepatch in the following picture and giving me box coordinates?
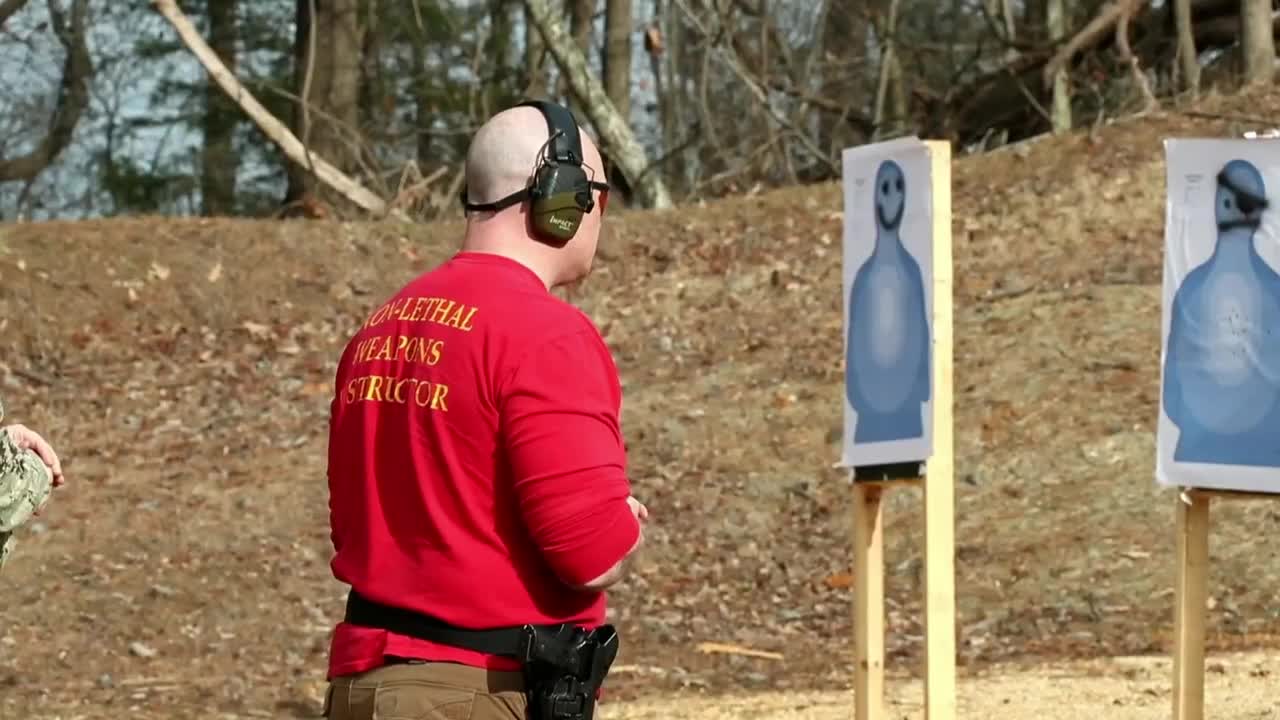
[1156,140,1280,492]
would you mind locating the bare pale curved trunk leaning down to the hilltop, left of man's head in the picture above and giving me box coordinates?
[151,0,408,222]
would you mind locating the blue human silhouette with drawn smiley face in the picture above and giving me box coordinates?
[845,160,931,443]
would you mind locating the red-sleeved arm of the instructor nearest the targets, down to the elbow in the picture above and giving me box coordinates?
[500,329,643,591]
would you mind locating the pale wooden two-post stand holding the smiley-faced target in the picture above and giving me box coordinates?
[852,141,956,720]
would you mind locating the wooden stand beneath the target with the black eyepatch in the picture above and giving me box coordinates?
[1174,488,1277,720]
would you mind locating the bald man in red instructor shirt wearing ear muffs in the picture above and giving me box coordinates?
[325,96,648,720]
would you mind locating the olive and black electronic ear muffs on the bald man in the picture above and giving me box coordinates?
[462,100,609,246]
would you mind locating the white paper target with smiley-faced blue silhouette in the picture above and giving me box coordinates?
[842,138,933,466]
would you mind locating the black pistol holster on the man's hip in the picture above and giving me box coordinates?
[520,625,618,720]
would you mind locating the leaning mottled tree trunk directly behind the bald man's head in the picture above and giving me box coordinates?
[525,0,671,208]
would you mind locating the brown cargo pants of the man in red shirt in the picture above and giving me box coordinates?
[324,661,527,720]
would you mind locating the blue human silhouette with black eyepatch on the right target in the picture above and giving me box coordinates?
[1162,160,1280,468]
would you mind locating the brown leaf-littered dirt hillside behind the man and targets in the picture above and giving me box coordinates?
[0,87,1280,717]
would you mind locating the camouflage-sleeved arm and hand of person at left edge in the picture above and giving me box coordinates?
[0,394,64,569]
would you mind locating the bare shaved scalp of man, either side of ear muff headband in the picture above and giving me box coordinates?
[466,108,604,204]
